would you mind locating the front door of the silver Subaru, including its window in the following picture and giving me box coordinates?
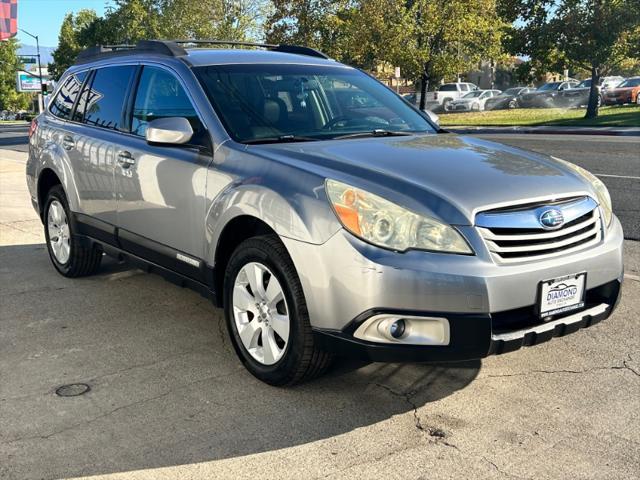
[115,65,212,277]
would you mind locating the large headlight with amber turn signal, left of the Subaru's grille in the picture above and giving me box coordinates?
[325,180,473,254]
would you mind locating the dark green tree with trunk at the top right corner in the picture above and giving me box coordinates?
[508,0,640,118]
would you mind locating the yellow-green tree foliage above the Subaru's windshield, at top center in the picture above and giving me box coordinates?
[266,0,505,108]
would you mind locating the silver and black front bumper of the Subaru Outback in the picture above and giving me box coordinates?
[283,217,623,361]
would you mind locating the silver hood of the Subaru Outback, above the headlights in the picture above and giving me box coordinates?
[248,134,592,225]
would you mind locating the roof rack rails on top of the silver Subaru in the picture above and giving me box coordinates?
[76,39,329,63]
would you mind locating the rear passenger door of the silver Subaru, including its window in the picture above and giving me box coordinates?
[70,65,136,233]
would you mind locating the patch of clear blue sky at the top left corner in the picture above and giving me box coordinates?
[17,0,111,47]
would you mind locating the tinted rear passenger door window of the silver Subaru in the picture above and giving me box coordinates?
[79,65,135,130]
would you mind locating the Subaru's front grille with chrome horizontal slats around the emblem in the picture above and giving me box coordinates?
[476,197,602,263]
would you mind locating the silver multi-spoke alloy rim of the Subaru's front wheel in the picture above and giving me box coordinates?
[232,262,290,365]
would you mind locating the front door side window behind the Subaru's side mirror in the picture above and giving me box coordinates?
[131,67,199,136]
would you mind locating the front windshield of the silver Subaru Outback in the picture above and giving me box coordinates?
[194,64,435,143]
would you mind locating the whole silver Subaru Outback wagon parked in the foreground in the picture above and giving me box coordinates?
[27,41,623,385]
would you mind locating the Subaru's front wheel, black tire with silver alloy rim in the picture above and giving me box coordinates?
[224,235,331,386]
